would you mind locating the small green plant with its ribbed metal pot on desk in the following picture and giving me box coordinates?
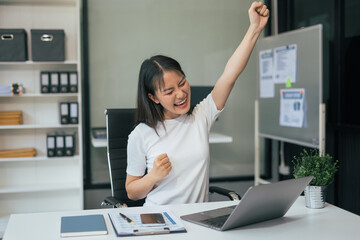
[293,149,338,208]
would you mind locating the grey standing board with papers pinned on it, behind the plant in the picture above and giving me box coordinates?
[256,25,323,148]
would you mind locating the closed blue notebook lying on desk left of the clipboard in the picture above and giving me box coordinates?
[60,214,108,237]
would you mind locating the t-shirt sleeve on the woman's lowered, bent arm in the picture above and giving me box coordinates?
[126,127,146,177]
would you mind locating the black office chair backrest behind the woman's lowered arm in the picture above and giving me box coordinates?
[105,108,144,207]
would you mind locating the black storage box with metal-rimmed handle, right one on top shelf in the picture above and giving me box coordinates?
[31,29,65,61]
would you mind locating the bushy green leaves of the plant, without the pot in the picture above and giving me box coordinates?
[293,149,339,186]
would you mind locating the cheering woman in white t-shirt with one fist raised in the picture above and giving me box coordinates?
[126,2,269,205]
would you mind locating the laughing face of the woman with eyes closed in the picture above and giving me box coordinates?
[148,71,191,120]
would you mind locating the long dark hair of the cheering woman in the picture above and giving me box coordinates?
[135,55,185,131]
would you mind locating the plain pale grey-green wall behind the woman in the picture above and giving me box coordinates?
[88,0,262,179]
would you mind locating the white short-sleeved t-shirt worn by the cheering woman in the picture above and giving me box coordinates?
[126,93,221,205]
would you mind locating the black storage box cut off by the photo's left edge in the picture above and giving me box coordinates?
[0,29,28,61]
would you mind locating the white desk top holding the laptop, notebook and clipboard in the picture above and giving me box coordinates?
[4,197,360,240]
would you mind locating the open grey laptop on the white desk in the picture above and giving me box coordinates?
[181,176,313,231]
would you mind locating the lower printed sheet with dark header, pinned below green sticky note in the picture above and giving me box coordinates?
[280,88,306,128]
